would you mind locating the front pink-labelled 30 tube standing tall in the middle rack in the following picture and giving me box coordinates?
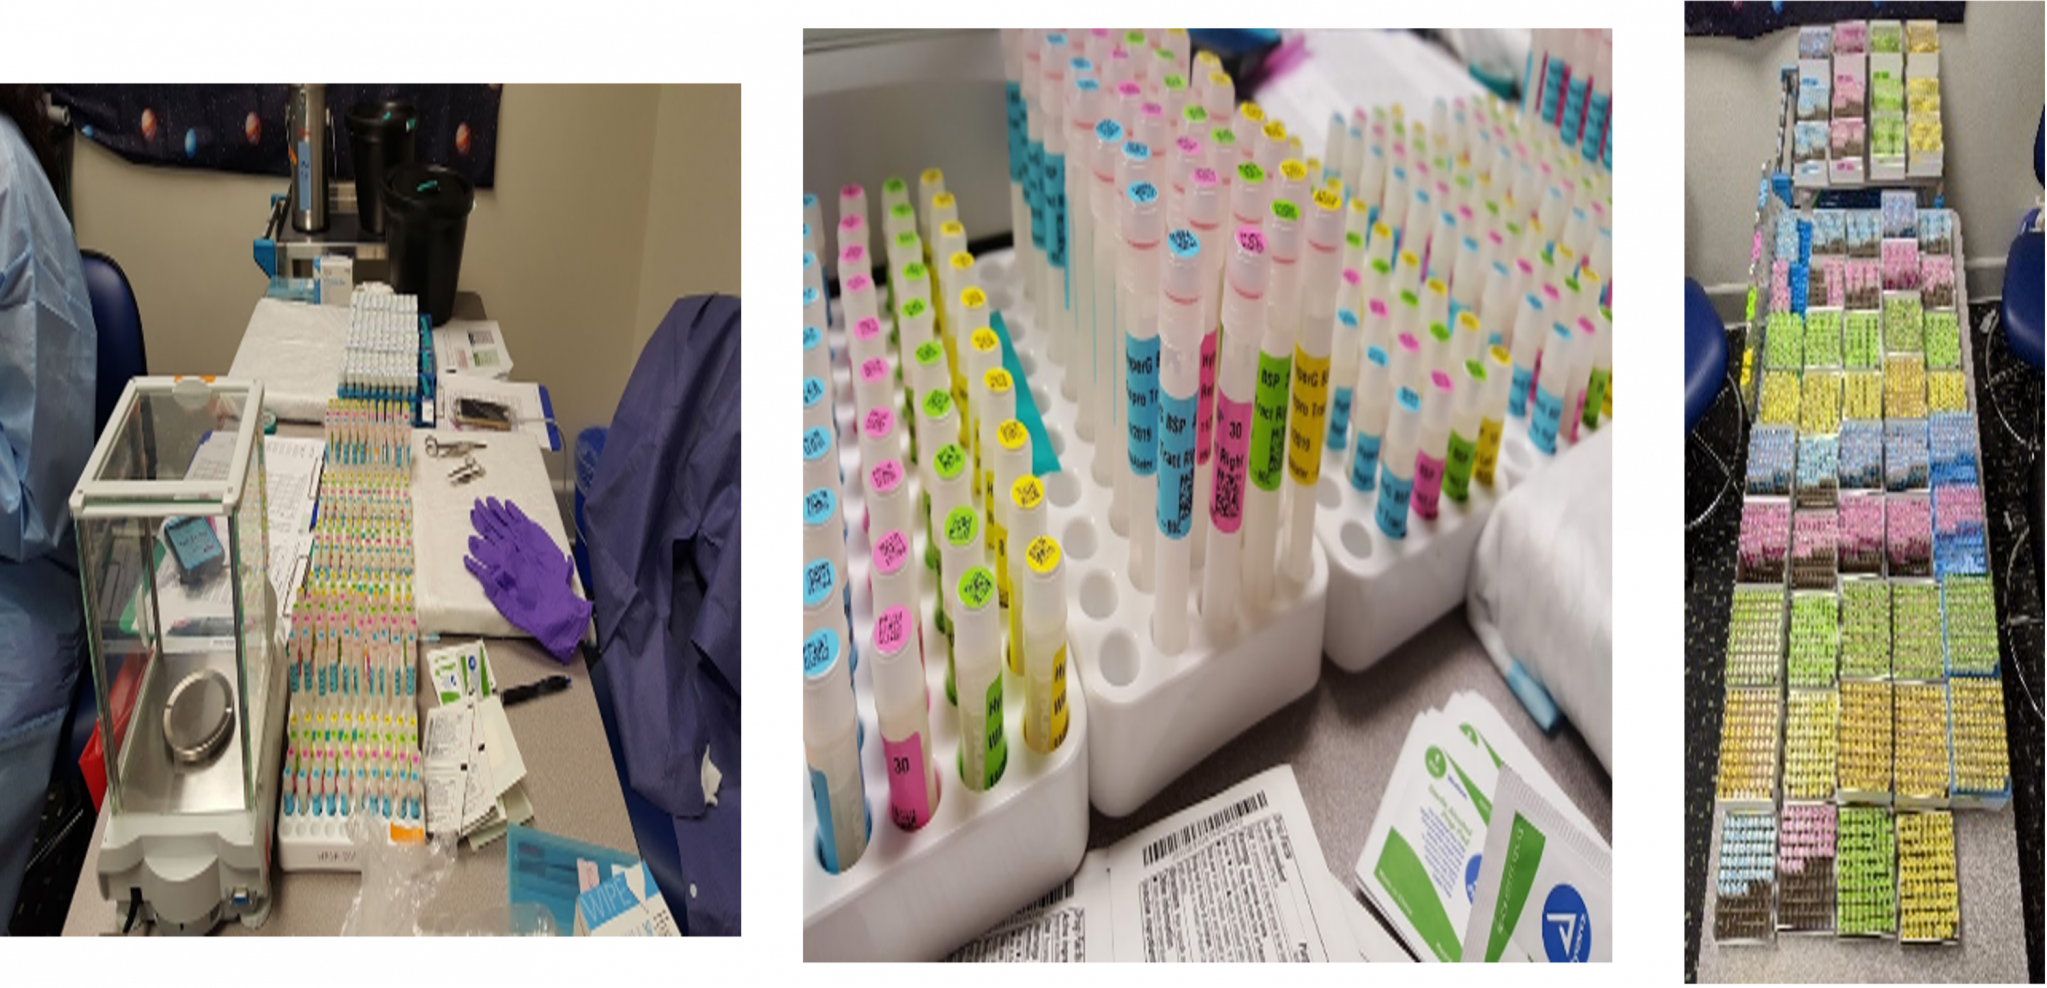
[1202,227,1271,630]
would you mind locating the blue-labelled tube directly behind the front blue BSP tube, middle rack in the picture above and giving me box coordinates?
[1109,180,1165,591]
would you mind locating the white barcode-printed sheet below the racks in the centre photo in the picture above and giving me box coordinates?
[946,765,1359,963]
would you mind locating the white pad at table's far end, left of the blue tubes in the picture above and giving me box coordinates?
[227,299,348,423]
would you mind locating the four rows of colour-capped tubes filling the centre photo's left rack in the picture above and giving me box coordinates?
[802,170,1069,871]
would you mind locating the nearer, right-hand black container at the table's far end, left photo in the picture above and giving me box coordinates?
[385,162,477,325]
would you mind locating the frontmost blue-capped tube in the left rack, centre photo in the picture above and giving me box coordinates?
[802,628,872,873]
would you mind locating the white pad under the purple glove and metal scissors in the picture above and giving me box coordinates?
[411,430,587,638]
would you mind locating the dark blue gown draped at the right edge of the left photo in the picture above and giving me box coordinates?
[585,295,741,937]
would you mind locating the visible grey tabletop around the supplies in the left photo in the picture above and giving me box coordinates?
[63,415,639,937]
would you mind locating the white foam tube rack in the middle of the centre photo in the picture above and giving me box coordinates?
[974,254,1329,816]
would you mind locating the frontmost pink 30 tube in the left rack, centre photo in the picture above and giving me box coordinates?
[874,601,938,830]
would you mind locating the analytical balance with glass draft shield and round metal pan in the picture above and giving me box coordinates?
[72,376,287,937]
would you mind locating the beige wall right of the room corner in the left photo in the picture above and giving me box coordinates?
[633,82,741,356]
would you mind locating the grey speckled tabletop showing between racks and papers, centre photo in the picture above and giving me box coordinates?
[1087,608,1613,961]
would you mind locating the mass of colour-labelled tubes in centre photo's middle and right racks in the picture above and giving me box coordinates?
[994,33,1611,653]
